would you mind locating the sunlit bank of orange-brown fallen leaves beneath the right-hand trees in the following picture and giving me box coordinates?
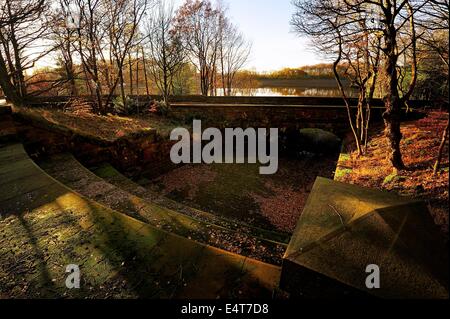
[336,111,449,240]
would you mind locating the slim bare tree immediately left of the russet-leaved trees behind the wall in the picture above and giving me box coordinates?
[147,0,186,105]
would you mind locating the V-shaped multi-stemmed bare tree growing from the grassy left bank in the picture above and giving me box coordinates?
[71,0,149,113]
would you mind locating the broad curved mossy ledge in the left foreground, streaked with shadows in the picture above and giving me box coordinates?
[0,144,280,298]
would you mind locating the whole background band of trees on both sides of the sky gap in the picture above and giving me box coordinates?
[0,0,449,169]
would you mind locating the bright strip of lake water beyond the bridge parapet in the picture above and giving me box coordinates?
[217,87,357,97]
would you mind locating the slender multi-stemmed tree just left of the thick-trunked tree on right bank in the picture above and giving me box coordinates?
[292,0,381,155]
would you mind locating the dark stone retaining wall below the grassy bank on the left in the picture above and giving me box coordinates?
[14,113,176,176]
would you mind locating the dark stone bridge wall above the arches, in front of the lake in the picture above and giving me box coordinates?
[166,97,426,137]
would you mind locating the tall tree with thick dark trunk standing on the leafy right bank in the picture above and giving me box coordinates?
[294,0,427,169]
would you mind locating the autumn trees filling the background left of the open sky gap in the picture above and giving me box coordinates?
[0,0,251,113]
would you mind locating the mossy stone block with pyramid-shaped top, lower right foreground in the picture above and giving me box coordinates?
[281,178,448,298]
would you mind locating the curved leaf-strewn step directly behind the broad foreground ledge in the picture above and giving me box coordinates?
[39,154,286,265]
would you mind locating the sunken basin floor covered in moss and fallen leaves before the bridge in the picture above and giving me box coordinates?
[144,155,335,235]
